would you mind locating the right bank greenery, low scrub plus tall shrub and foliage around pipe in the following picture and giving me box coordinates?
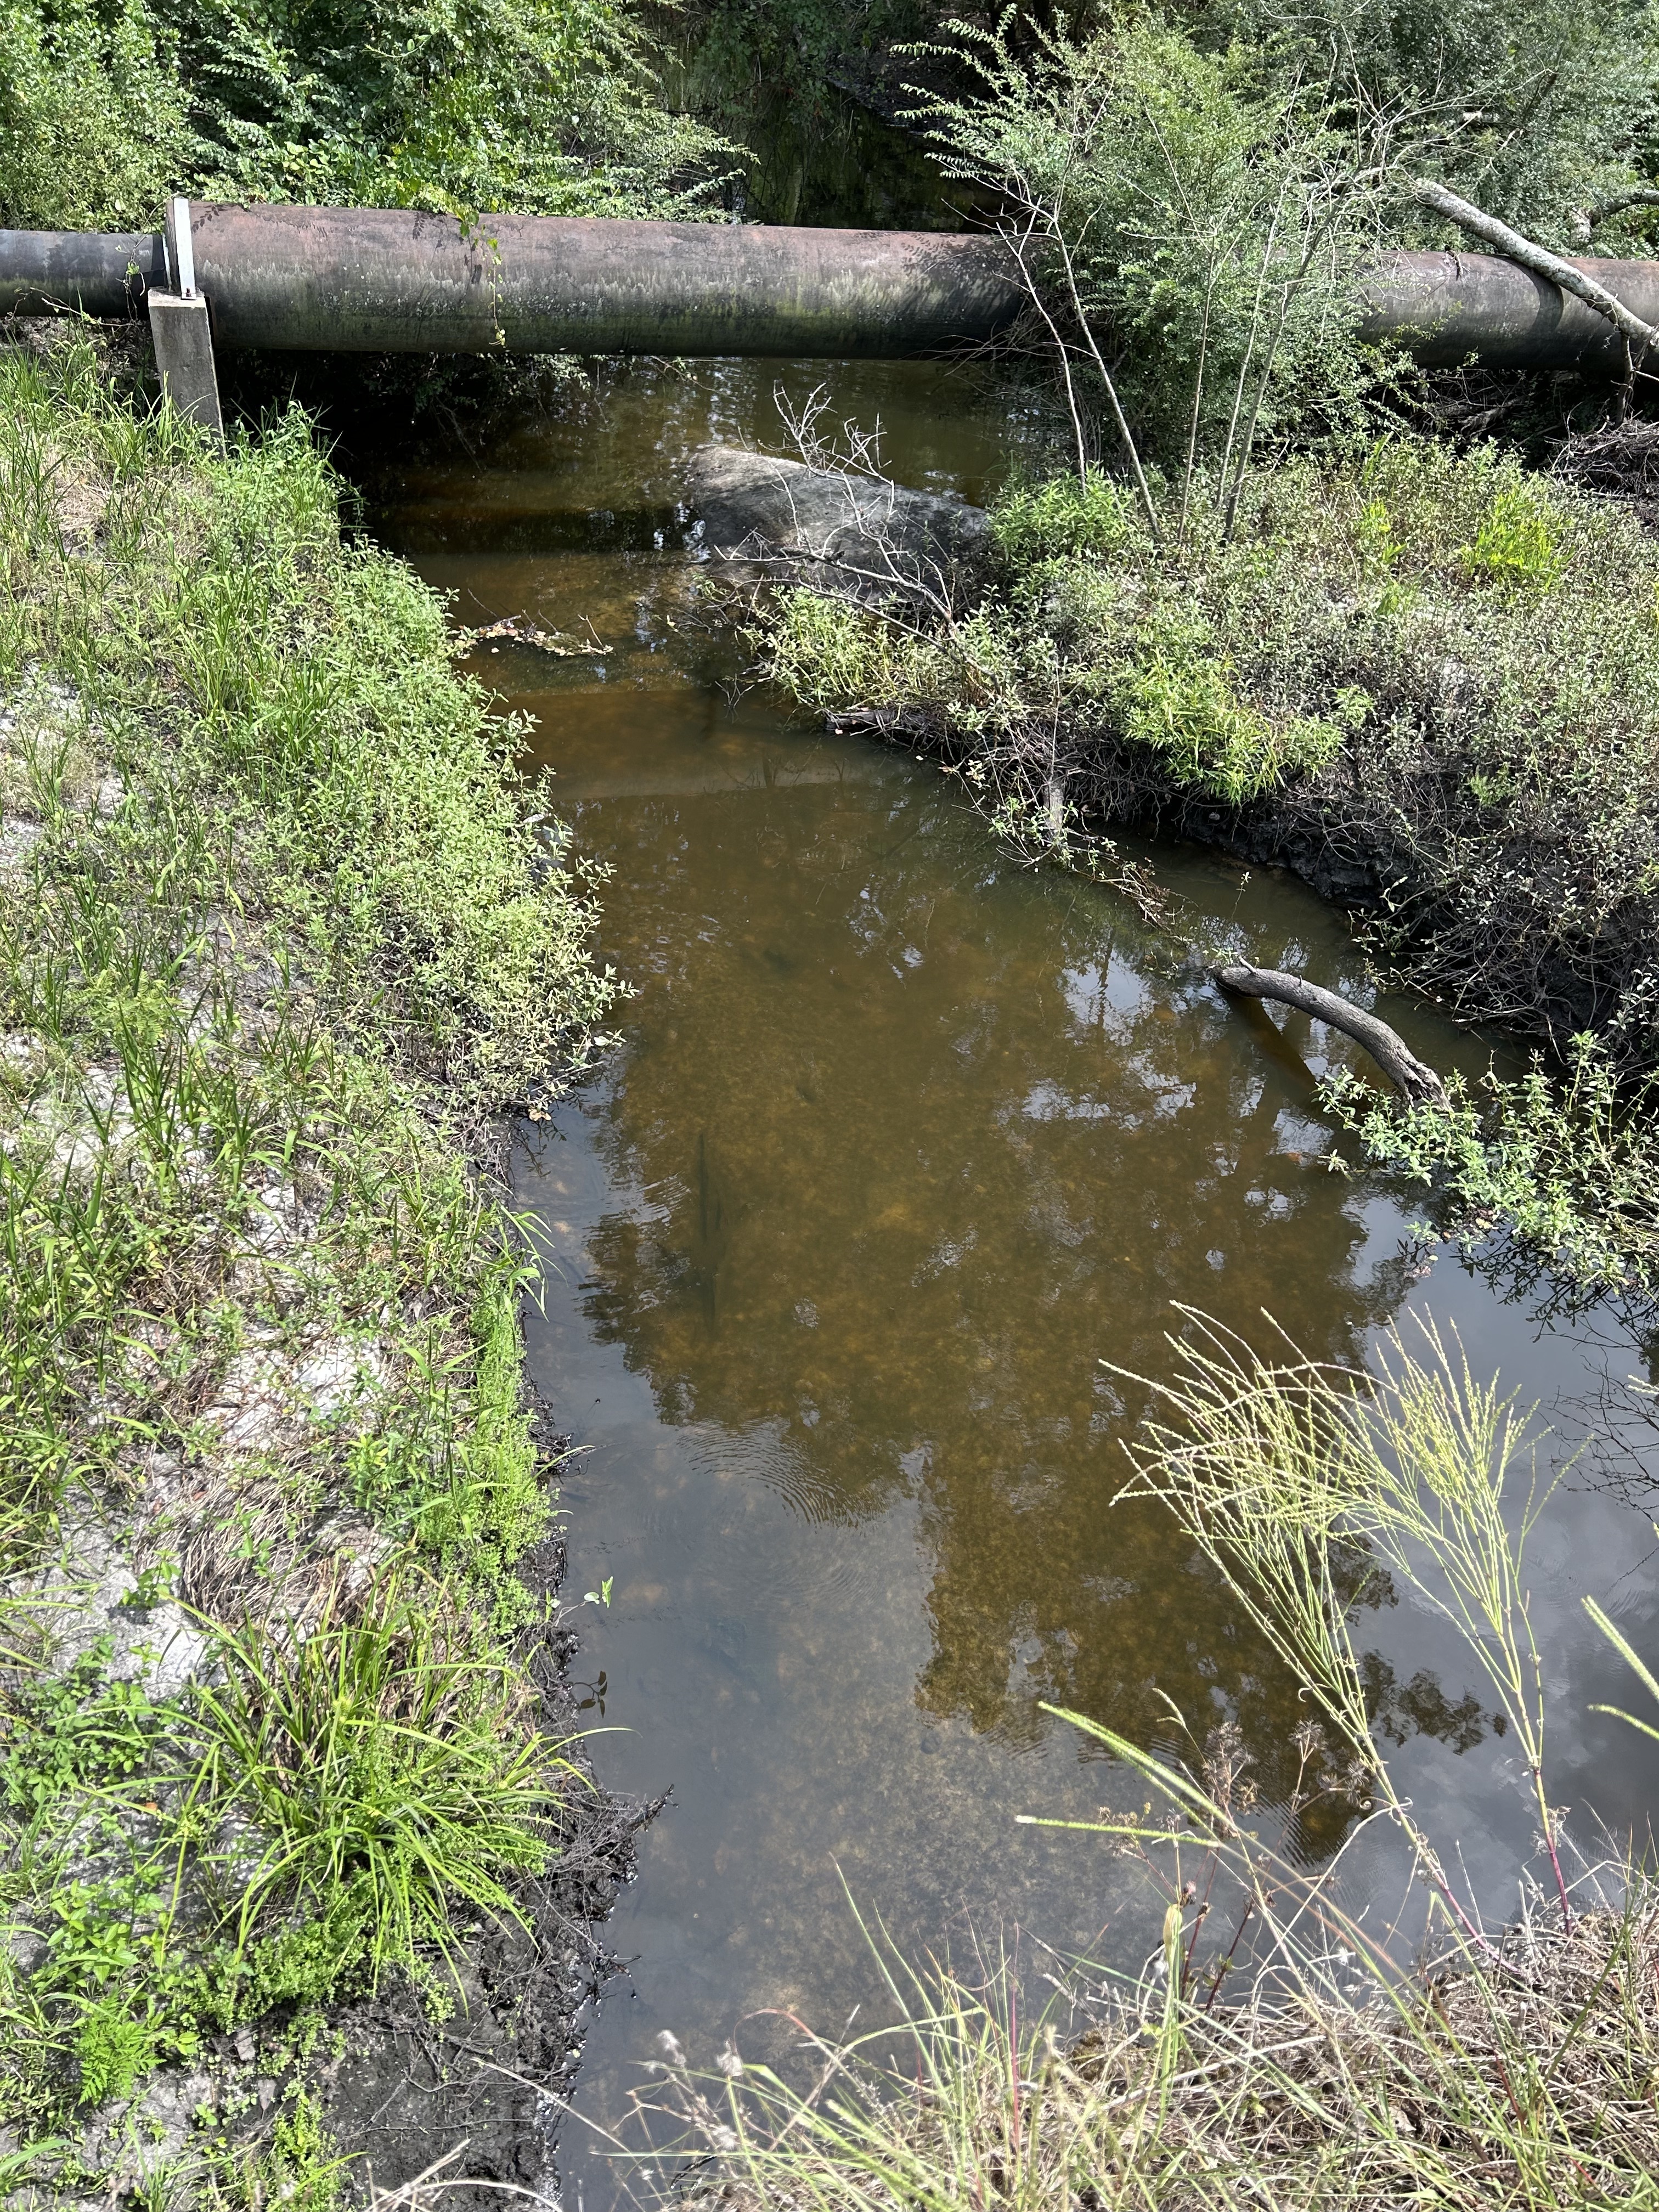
[757,7,1659,1294]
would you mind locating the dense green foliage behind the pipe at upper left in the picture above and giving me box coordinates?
[0,0,725,228]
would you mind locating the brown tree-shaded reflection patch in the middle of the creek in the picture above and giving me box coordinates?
[566,737,1469,1790]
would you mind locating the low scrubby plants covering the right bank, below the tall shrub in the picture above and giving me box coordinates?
[765,438,1659,1294]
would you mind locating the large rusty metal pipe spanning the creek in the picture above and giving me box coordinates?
[0,201,1659,371]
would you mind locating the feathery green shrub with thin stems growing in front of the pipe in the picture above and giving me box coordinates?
[916,9,1380,478]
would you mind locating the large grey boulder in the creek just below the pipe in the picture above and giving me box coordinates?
[688,444,986,600]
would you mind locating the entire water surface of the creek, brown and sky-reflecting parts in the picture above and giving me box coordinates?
[374,363,1659,2199]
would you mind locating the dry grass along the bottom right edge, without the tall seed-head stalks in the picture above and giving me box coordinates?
[619,1714,1659,2212]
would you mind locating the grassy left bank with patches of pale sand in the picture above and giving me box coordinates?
[0,323,608,2201]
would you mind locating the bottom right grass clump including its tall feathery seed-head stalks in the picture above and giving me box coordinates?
[584,1314,1659,2212]
